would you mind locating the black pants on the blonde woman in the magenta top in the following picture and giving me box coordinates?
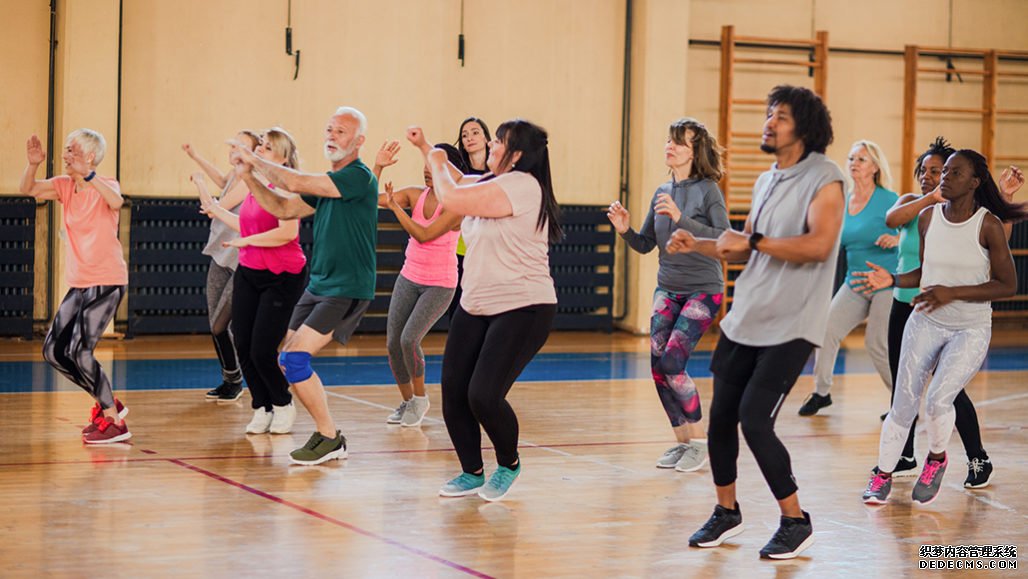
[232,265,307,410]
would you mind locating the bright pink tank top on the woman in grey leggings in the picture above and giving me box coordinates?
[400,187,461,288]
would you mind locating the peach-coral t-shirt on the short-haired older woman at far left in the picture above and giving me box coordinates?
[52,175,129,288]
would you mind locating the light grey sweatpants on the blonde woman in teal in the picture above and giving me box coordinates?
[814,284,892,396]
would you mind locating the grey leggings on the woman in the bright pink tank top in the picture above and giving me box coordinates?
[386,275,455,384]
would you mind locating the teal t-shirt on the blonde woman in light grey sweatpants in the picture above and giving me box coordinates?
[841,187,898,291]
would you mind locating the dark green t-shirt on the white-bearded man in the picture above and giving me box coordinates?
[303,159,378,299]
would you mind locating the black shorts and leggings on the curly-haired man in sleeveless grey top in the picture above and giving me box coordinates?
[707,334,814,501]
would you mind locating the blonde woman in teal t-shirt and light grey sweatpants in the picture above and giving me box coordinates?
[800,141,900,417]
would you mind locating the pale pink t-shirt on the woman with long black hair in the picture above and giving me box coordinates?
[461,171,557,316]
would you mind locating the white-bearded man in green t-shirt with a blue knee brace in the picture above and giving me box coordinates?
[232,107,378,465]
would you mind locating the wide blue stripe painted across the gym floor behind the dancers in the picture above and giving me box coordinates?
[0,348,1028,393]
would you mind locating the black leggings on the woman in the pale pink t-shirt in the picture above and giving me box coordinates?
[442,304,557,474]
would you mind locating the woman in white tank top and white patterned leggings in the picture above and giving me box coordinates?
[857,149,1028,504]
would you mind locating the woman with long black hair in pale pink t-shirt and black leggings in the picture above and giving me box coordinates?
[429,119,562,501]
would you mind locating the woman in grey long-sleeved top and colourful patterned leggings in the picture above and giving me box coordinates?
[607,117,729,472]
